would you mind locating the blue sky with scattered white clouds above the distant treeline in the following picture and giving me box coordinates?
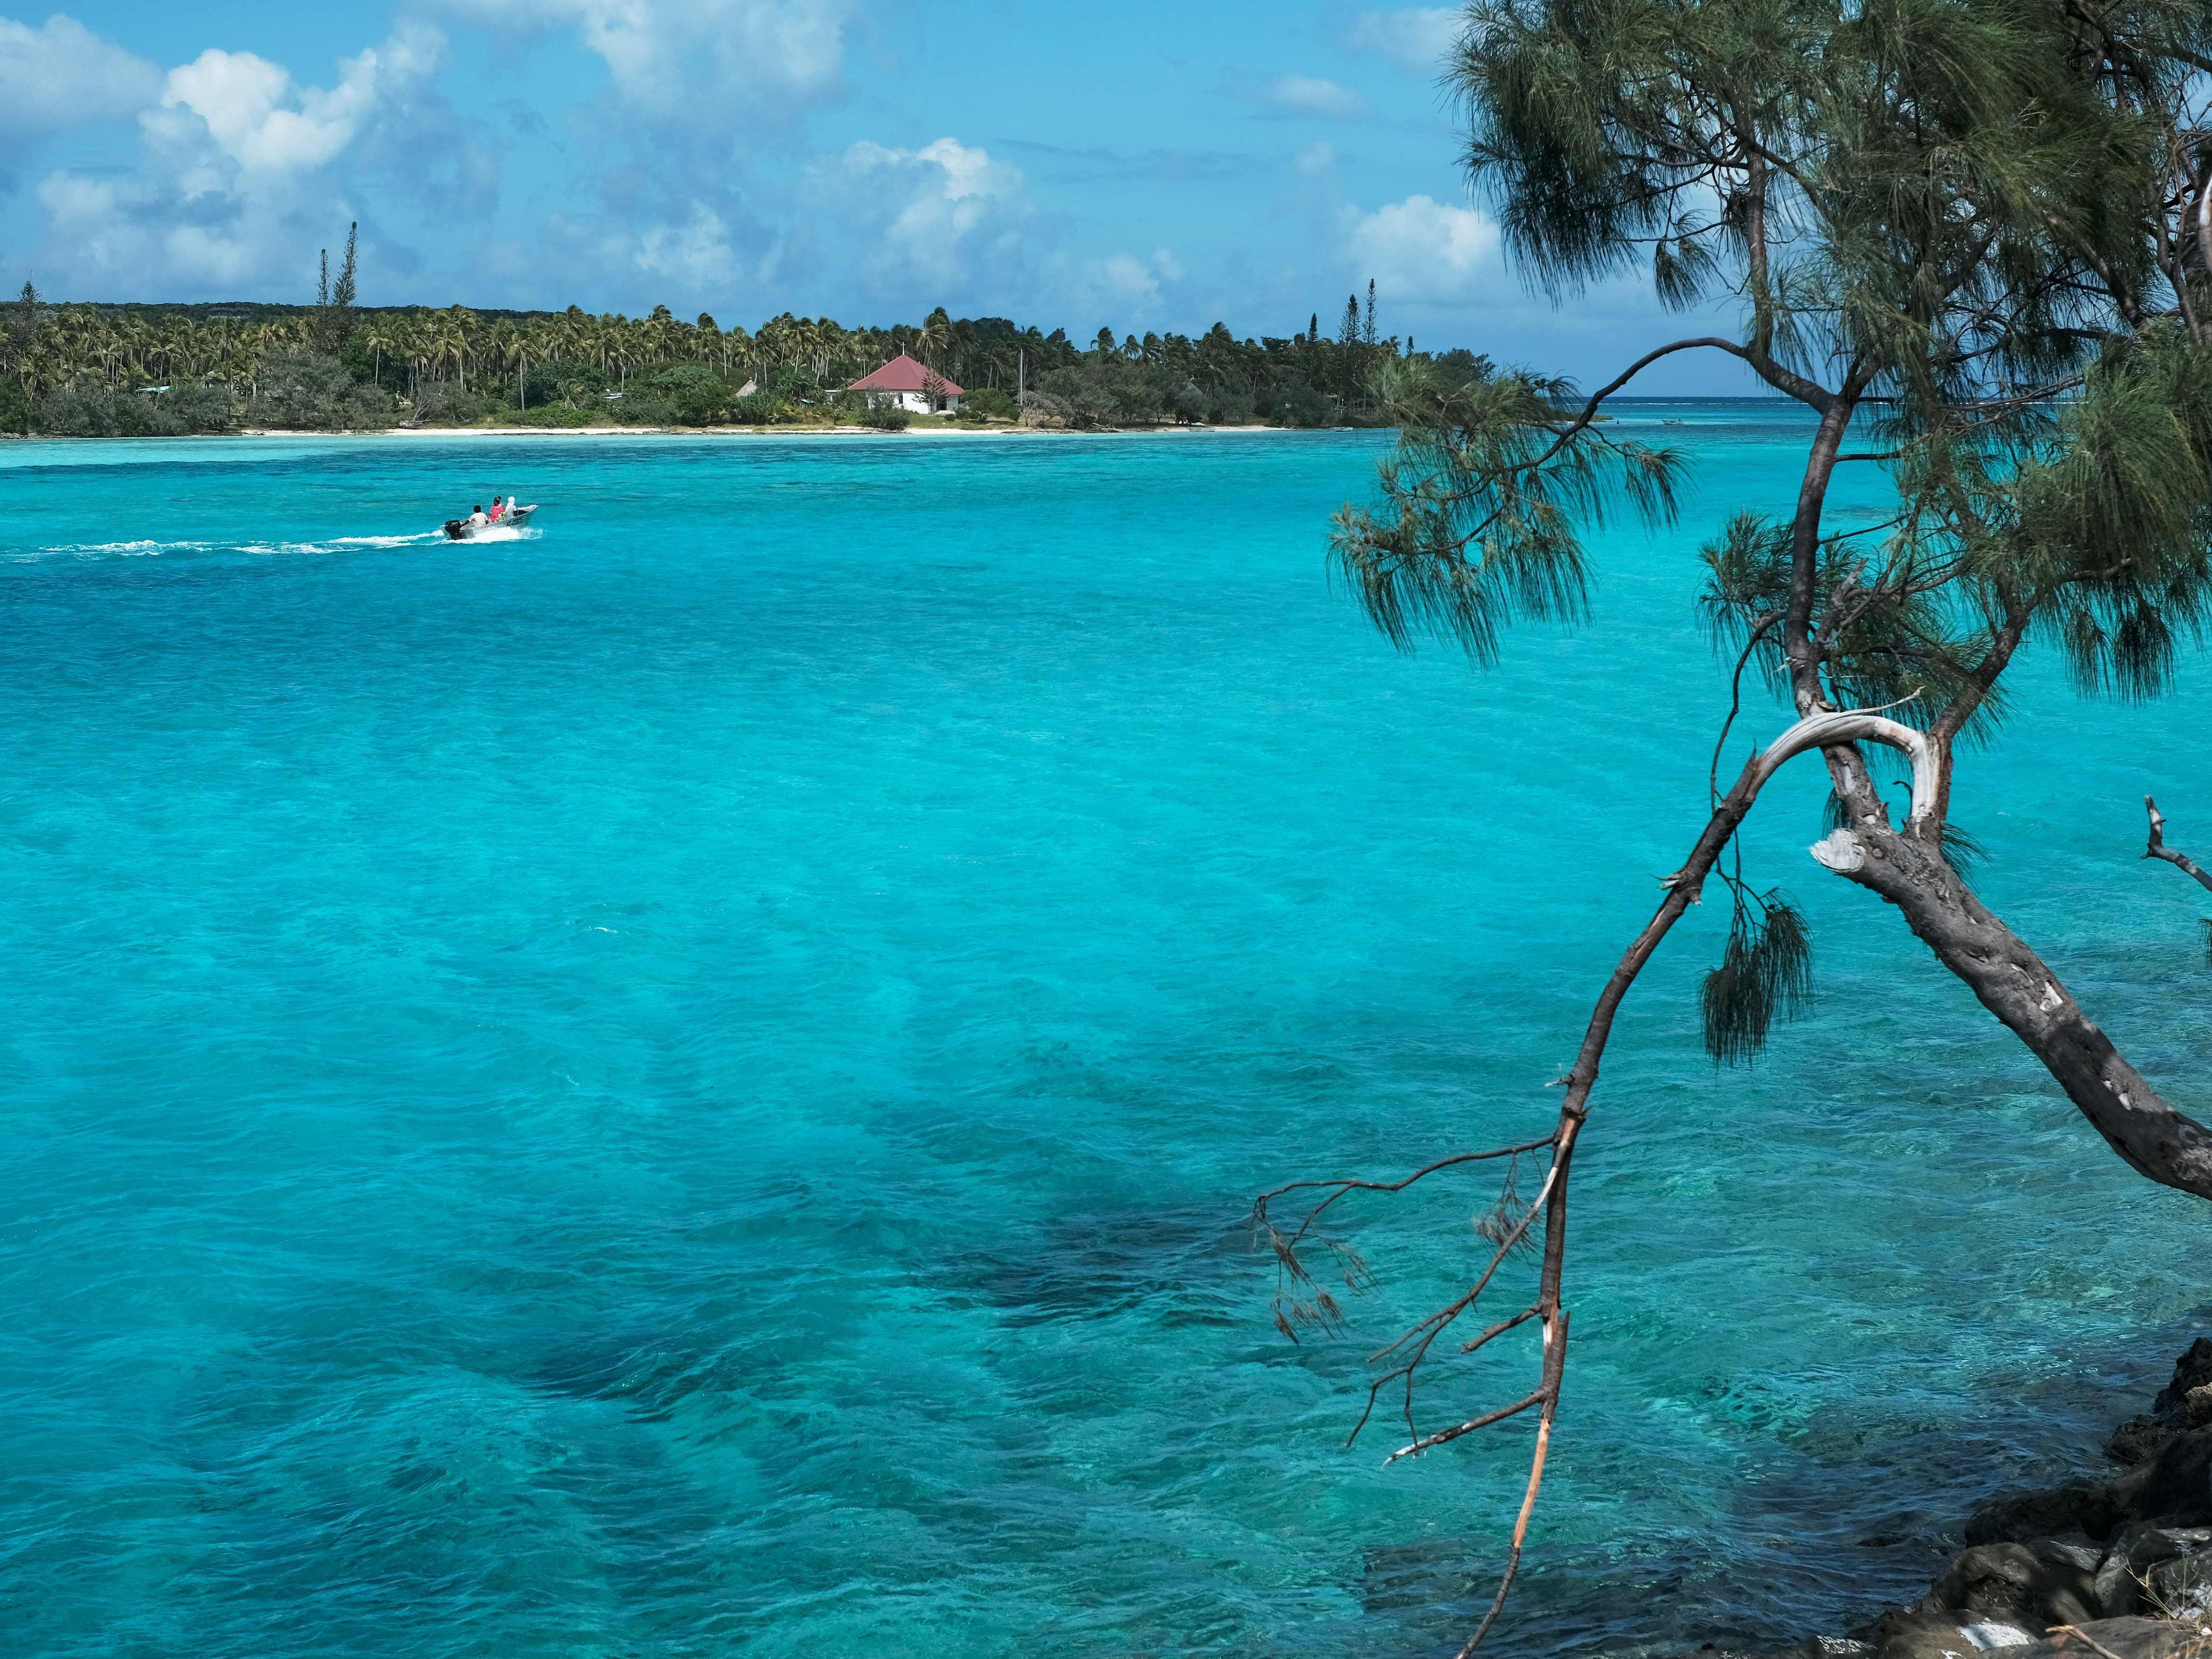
[0,0,1745,391]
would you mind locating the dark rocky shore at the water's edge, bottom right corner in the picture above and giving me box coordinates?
[1701,1338,2212,1659]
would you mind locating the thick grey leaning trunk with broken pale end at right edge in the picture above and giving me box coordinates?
[1814,821,2212,1199]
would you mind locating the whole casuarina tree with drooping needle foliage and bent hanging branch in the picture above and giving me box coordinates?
[1257,0,2212,1652]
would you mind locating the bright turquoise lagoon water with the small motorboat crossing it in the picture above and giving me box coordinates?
[0,405,2212,1659]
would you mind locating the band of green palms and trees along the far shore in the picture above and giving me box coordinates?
[0,253,1489,436]
